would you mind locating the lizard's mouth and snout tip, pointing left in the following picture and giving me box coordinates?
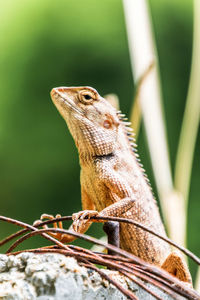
[50,87,82,114]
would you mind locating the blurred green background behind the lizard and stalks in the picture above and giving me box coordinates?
[0,0,200,274]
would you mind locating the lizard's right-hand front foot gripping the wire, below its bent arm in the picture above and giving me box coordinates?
[72,210,98,233]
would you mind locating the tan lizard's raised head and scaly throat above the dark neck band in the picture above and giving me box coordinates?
[51,87,120,157]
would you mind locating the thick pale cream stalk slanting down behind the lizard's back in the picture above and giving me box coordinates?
[123,0,185,244]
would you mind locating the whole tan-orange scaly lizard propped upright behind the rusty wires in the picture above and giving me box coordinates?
[41,86,192,284]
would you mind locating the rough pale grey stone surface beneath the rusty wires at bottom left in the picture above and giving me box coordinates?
[0,253,184,300]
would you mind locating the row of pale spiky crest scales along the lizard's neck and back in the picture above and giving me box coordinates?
[117,110,152,189]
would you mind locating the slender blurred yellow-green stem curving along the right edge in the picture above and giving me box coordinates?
[175,0,200,291]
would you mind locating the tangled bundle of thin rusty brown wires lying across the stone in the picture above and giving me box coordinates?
[0,216,200,300]
